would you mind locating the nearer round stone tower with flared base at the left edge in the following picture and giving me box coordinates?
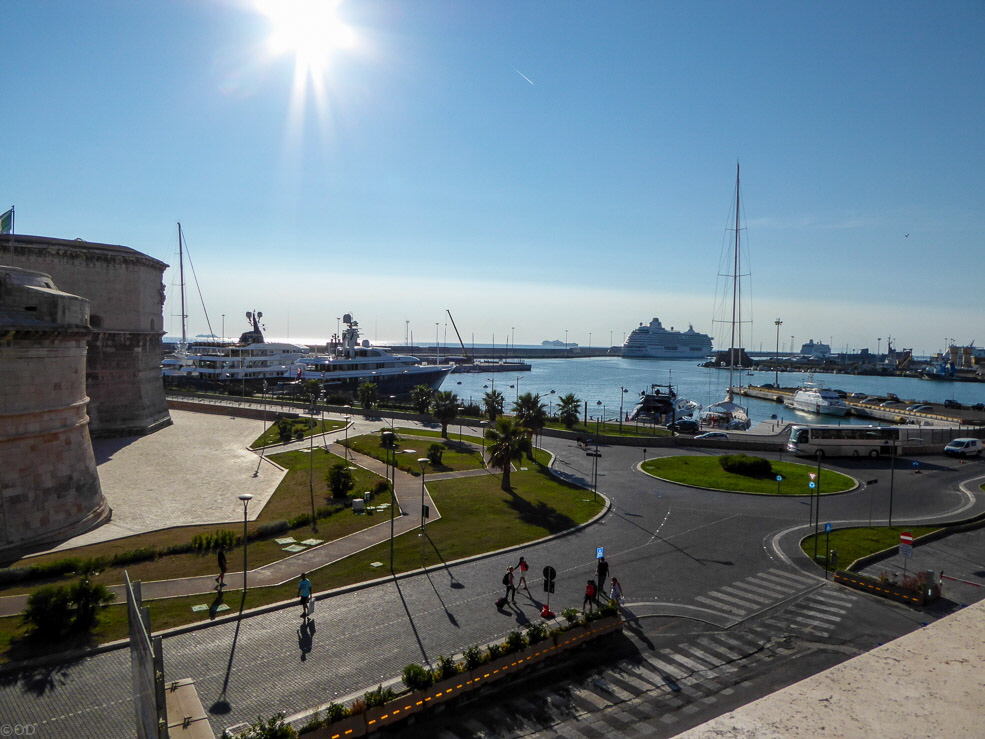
[0,266,111,554]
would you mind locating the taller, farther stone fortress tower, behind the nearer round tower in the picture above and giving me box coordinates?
[0,234,171,437]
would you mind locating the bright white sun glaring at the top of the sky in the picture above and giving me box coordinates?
[256,0,355,77]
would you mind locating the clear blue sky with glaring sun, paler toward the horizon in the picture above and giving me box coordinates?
[0,0,985,355]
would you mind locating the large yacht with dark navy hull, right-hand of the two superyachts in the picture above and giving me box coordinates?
[296,313,454,397]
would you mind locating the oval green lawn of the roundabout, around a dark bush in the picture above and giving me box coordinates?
[643,455,855,495]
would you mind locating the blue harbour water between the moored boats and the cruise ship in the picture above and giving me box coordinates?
[441,357,985,425]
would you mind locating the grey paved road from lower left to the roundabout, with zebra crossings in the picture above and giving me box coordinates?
[0,430,985,738]
